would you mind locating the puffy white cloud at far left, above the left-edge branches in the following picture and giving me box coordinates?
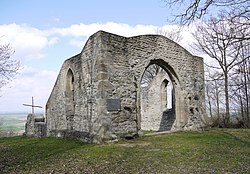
[0,23,57,60]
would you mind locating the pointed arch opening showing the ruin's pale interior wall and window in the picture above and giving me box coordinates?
[141,64,176,131]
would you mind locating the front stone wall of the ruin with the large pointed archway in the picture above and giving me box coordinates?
[91,32,204,135]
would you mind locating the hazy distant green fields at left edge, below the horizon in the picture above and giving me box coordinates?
[0,113,28,131]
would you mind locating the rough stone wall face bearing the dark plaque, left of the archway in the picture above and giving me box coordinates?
[97,33,138,139]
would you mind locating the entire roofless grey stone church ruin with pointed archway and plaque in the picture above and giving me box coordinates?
[24,31,205,142]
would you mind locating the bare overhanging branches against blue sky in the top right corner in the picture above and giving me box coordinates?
[163,0,250,25]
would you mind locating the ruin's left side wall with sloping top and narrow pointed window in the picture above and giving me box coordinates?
[46,34,102,141]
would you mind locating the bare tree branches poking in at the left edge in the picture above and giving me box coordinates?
[0,44,20,89]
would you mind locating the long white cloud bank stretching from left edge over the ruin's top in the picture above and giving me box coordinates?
[0,22,195,61]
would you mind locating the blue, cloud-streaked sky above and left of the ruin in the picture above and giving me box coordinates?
[0,0,195,113]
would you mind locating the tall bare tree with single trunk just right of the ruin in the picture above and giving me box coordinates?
[193,16,249,125]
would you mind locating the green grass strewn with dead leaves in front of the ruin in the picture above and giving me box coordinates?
[0,129,250,174]
